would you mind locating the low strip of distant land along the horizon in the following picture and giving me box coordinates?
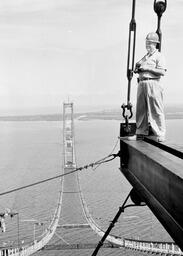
[0,105,183,121]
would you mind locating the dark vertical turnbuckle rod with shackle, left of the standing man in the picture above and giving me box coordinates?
[121,0,136,129]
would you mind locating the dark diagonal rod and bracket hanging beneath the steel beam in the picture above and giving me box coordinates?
[91,189,146,256]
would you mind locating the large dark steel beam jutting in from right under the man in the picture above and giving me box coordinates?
[120,135,183,250]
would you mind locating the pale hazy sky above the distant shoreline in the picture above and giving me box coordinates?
[0,0,183,115]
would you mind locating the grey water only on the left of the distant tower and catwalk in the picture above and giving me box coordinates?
[0,122,62,245]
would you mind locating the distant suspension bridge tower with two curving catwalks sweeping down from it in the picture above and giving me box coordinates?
[0,103,183,256]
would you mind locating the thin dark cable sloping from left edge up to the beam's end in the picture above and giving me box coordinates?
[0,151,120,196]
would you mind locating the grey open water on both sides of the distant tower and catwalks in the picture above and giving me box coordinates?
[0,120,183,251]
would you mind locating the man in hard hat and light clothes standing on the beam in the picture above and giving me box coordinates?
[135,32,166,142]
